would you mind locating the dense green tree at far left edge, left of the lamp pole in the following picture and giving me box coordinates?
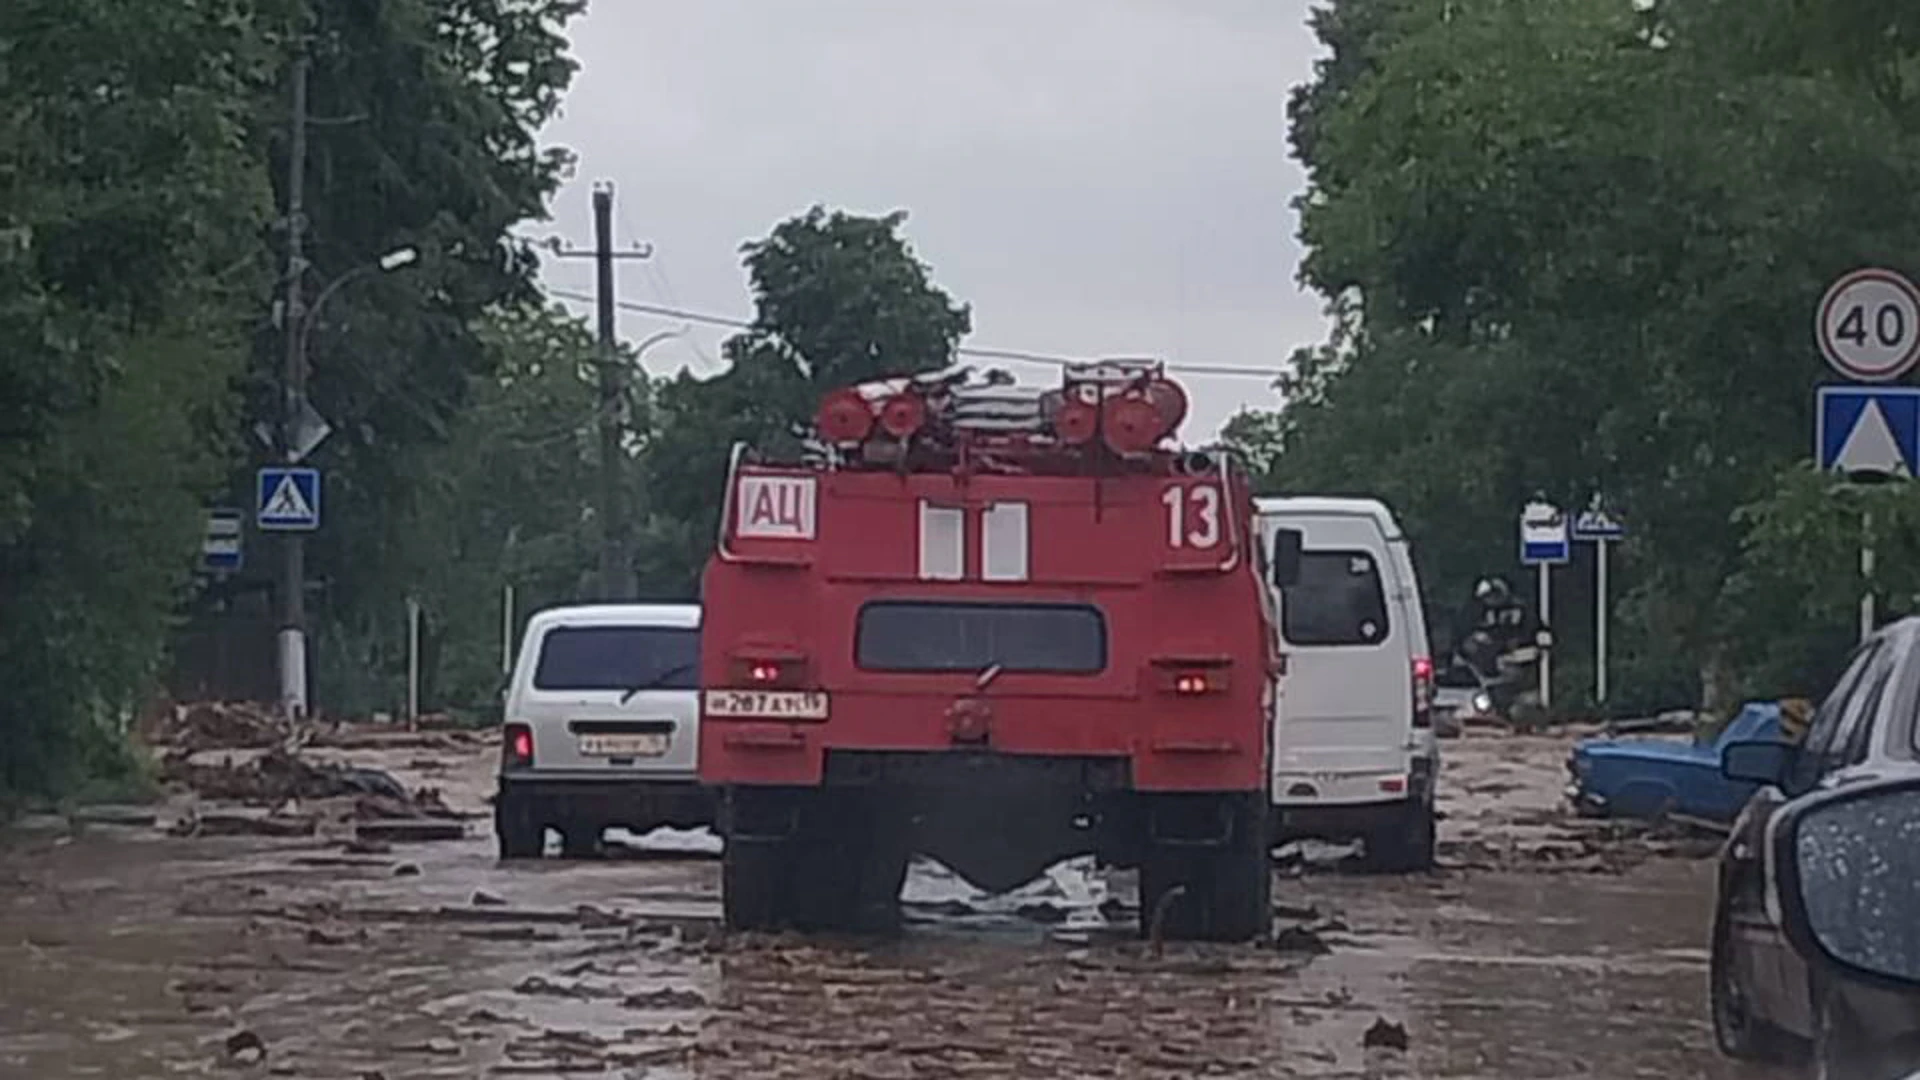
[0,0,273,796]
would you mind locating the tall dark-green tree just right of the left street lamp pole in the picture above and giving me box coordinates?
[236,0,584,713]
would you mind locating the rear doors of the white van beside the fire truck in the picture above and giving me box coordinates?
[1275,515,1419,801]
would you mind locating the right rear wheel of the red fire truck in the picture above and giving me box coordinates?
[1140,796,1273,942]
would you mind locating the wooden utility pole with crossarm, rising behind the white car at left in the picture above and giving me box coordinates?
[549,181,653,600]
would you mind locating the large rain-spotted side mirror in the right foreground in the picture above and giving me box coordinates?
[1772,776,1920,992]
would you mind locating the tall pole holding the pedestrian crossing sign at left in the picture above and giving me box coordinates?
[280,50,309,721]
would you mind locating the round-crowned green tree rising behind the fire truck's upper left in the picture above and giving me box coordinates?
[641,206,972,590]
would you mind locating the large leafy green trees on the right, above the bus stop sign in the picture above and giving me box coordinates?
[1273,0,1920,711]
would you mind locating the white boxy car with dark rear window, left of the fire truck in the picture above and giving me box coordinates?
[493,603,712,859]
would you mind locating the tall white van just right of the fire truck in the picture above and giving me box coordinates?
[1258,498,1440,871]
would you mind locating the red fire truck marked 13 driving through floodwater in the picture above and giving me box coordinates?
[699,361,1300,940]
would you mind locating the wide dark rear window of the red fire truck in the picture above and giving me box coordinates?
[854,600,1106,675]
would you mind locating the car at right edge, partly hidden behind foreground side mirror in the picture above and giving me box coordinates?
[1711,619,1920,1080]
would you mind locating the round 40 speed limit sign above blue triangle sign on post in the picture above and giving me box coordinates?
[1814,267,1920,640]
